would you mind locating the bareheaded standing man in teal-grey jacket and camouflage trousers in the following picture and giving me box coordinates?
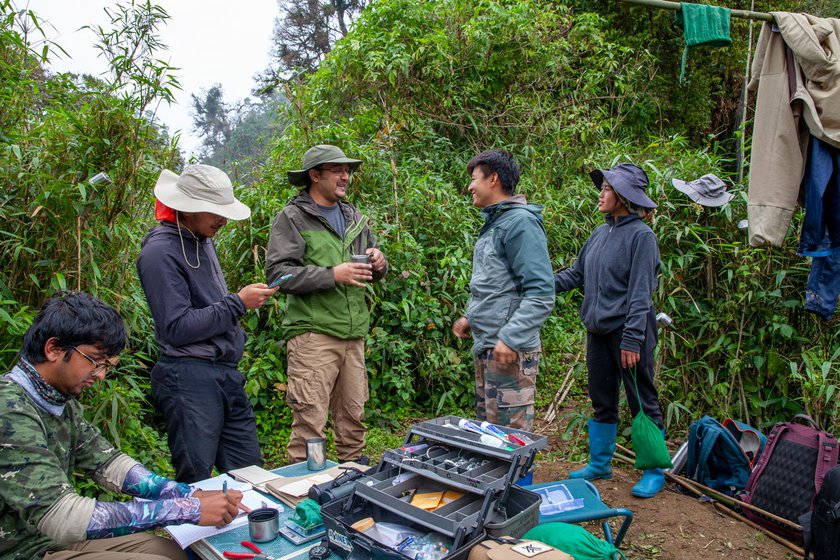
[452,150,554,430]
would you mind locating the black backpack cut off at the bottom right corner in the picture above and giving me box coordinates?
[803,467,840,560]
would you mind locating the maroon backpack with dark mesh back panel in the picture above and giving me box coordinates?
[739,414,838,542]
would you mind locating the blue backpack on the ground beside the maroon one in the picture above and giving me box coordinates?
[685,416,767,495]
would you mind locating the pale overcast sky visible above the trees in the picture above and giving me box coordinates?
[23,0,278,156]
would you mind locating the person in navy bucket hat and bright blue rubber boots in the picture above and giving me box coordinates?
[554,163,665,498]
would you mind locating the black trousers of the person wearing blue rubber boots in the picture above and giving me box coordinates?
[586,309,664,428]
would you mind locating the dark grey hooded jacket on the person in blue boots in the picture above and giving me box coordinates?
[554,214,659,352]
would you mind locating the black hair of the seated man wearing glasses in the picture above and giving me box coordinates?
[20,291,125,364]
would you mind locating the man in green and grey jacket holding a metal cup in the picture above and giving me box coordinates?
[266,144,388,461]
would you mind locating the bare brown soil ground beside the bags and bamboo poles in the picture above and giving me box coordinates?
[534,430,800,560]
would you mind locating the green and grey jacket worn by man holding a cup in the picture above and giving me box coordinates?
[266,190,387,340]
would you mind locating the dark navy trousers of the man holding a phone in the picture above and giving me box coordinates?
[152,357,262,483]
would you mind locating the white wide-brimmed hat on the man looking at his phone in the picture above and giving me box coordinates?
[155,164,251,220]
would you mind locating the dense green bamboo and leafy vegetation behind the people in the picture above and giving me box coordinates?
[0,0,840,472]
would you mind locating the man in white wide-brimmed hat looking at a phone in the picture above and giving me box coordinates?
[137,165,277,482]
